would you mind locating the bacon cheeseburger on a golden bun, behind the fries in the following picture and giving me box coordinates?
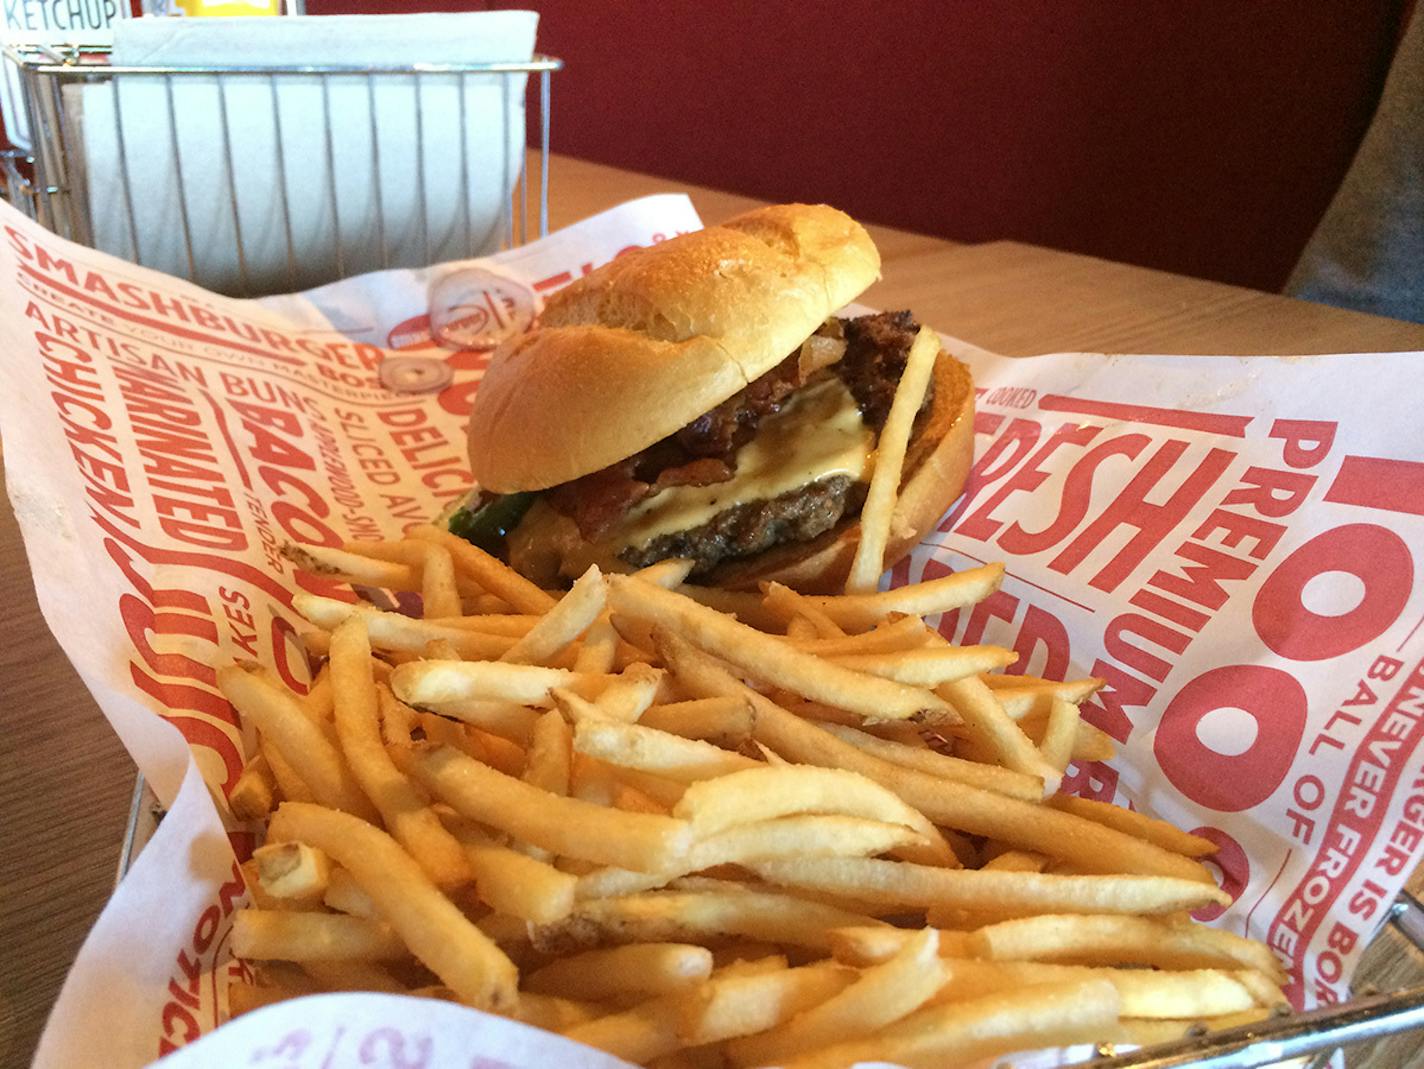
[447,204,974,592]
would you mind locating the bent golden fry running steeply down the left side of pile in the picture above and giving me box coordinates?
[329,616,474,892]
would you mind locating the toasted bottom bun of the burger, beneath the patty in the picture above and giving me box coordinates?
[698,350,974,594]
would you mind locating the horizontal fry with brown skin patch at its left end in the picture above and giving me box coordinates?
[534,881,879,951]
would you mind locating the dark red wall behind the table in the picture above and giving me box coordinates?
[309,0,1407,289]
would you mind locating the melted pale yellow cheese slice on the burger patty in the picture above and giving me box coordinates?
[608,377,874,547]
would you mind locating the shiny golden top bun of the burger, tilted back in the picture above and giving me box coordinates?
[470,204,880,494]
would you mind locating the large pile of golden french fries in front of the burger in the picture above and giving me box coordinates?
[219,527,1284,1068]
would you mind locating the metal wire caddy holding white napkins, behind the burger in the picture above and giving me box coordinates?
[3,46,562,296]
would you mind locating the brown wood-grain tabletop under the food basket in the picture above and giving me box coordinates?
[0,157,1424,1066]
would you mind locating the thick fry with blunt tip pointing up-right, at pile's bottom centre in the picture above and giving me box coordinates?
[728,928,948,1066]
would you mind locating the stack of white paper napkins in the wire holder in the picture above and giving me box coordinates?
[75,11,538,293]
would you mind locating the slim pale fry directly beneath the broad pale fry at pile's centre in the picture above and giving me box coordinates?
[577,816,924,900]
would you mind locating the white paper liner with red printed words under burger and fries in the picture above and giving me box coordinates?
[0,195,1424,1068]
